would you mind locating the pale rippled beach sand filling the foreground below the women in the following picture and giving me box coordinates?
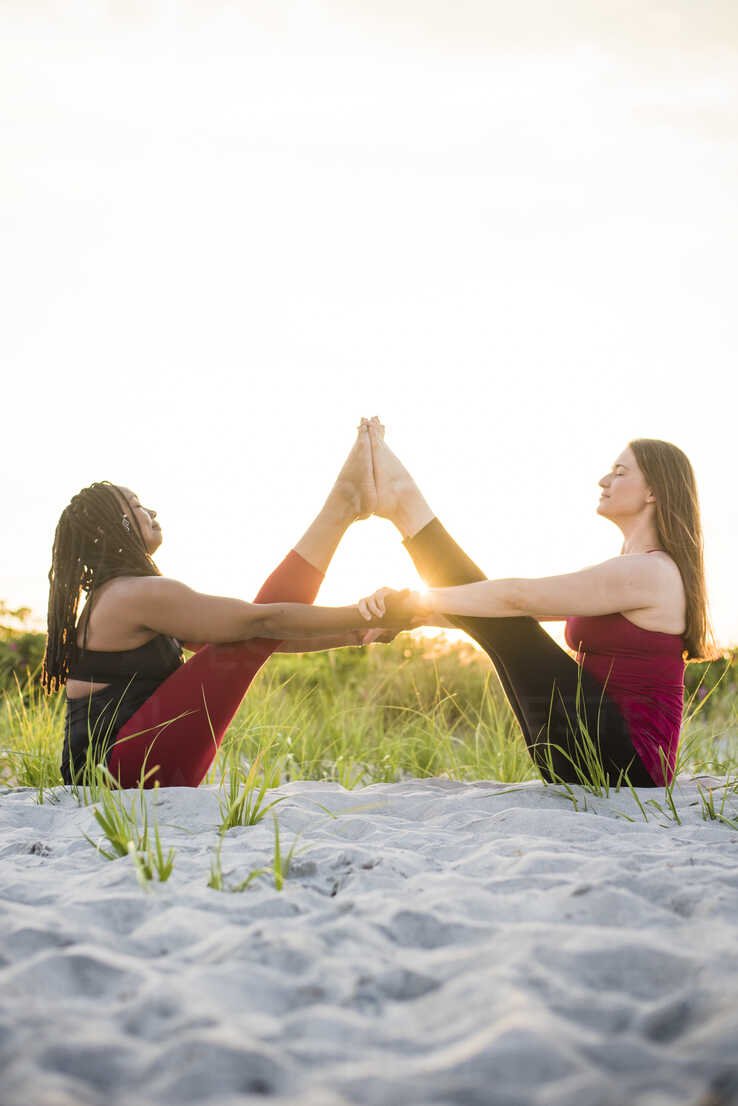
[0,778,738,1106]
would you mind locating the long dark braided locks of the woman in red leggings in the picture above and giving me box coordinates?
[41,480,162,692]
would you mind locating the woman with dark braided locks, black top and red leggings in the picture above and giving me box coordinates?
[43,419,404,787]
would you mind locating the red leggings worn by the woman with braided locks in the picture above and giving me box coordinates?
[108,550,323,787]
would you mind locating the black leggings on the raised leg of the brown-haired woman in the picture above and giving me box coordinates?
[404,519,656,787]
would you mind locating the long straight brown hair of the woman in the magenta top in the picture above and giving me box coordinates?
[628,438,720,660]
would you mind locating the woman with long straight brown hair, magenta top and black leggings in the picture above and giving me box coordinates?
[360,418,715,786]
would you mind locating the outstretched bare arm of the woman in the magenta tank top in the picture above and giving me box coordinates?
[419,554,664,622]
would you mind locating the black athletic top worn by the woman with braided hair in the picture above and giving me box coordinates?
[61,634,183,784]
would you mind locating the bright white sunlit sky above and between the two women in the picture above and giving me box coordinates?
[0,0,738,645]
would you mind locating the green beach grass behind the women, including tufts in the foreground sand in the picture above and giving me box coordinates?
[0,634,738,893]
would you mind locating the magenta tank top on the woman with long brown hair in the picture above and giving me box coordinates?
[565,550,685,787]
